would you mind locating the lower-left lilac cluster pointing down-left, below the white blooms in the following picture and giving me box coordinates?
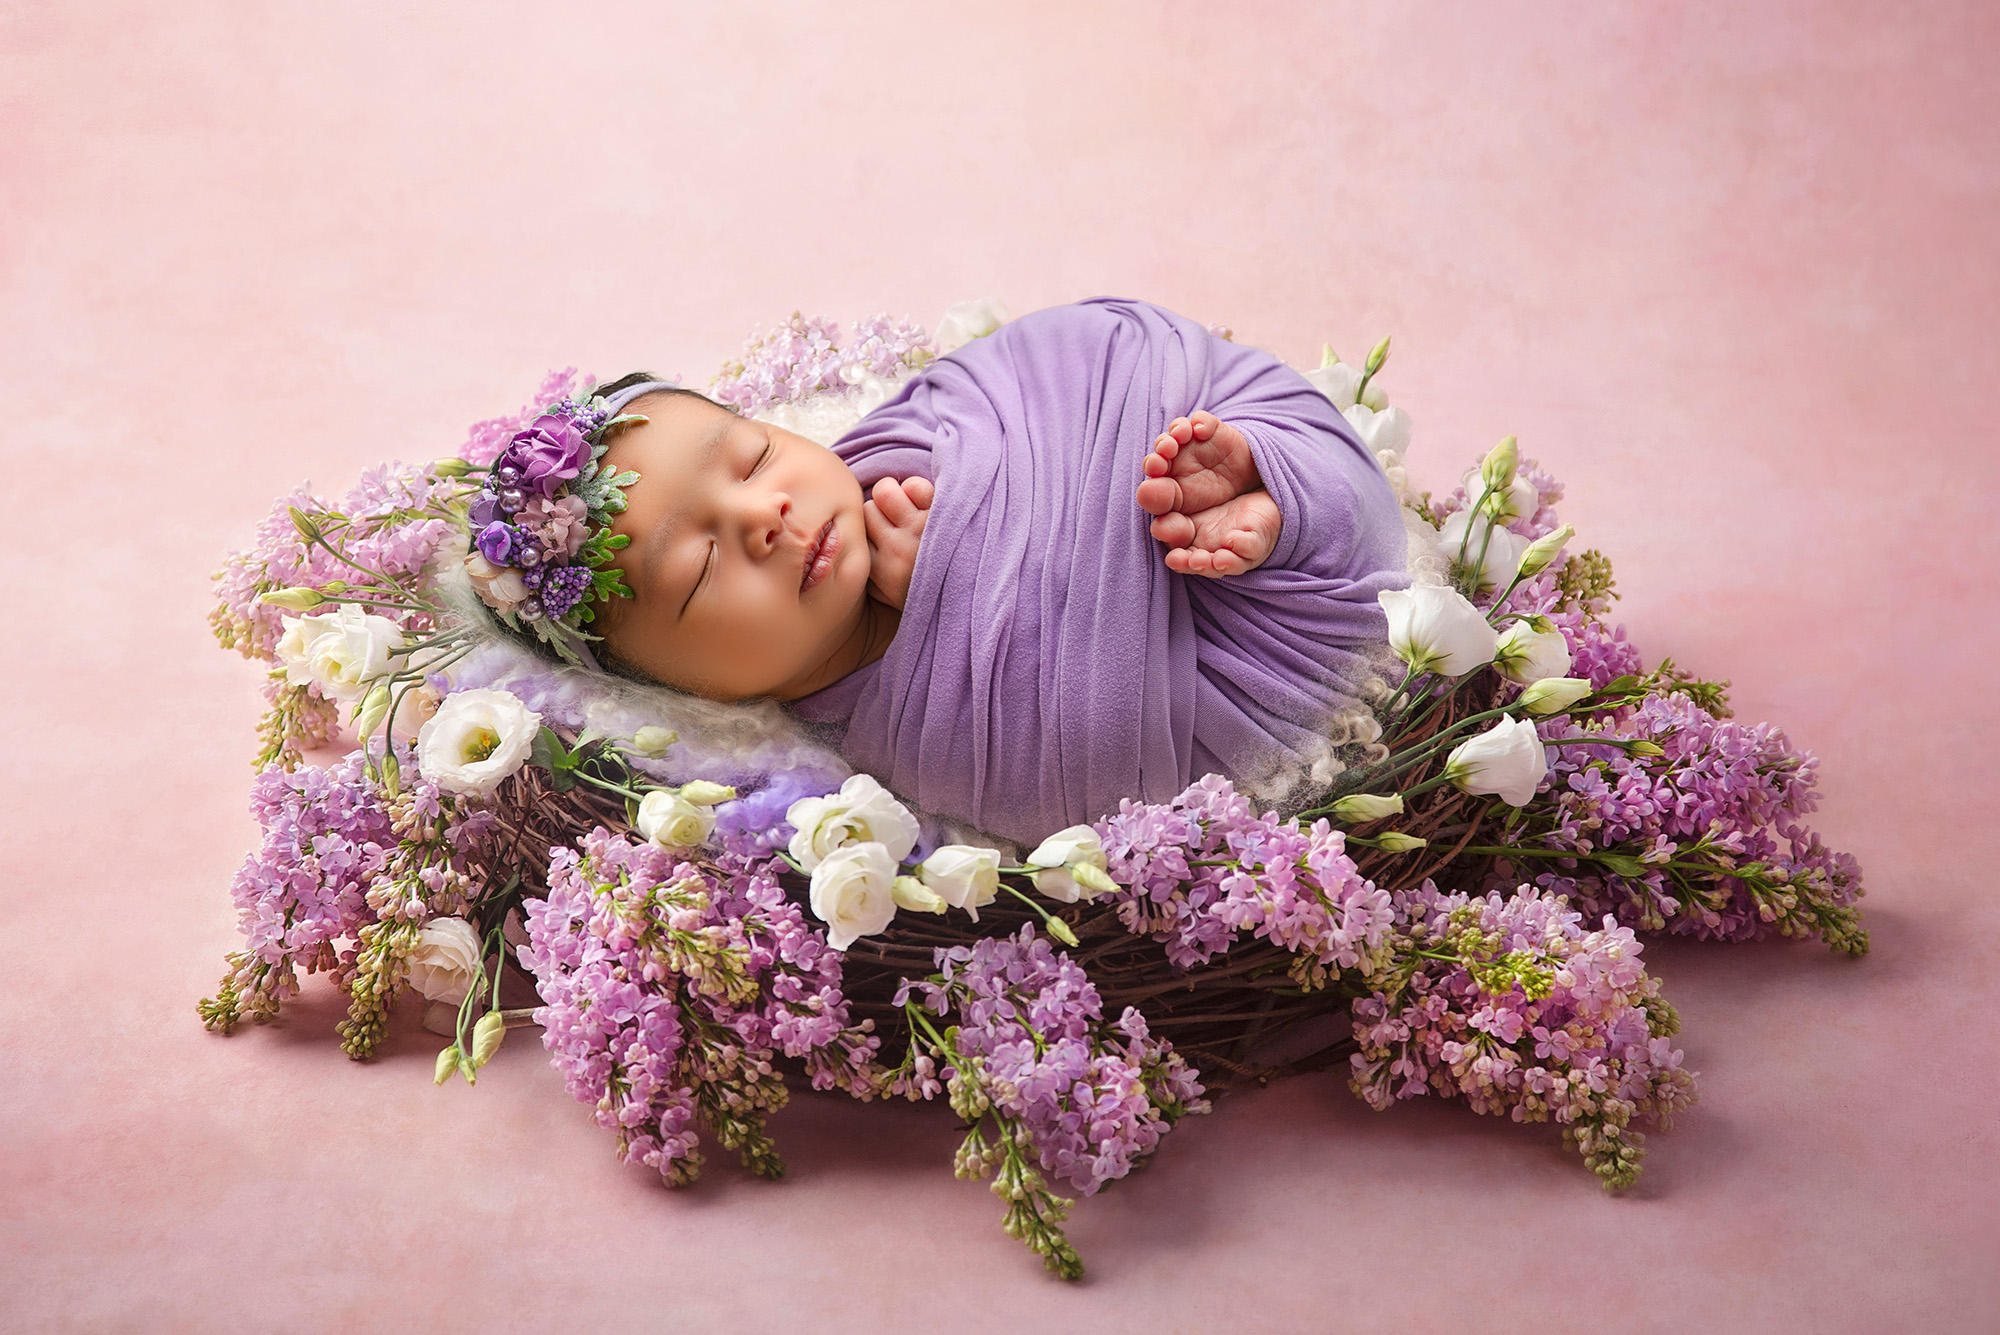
[202,755,396,1033]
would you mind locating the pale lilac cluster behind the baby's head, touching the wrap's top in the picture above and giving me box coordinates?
[708,312,932,418]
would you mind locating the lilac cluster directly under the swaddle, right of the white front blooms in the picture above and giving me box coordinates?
[1096,775,1392,987]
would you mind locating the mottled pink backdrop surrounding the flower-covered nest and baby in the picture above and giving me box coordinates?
[0,0,2000,1331]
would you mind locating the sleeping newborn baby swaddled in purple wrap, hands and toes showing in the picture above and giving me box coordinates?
[598,298,1408,841]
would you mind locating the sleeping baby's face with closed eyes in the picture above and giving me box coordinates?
[594,394,870,699]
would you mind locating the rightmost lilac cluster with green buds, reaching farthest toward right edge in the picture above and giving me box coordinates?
[1512,693,1866,953]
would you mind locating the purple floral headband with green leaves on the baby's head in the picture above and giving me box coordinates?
[466,382,668,666]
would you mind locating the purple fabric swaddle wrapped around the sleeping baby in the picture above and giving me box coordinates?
[794,298,1408,841]
